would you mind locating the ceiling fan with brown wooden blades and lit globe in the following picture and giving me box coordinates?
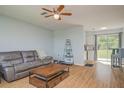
[41,5,72,20]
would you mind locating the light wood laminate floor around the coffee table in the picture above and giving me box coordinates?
[0,63,124,88]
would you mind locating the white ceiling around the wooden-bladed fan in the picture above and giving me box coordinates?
[0,5,124,30]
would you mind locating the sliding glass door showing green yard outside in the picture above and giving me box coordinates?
[96,34,120,62]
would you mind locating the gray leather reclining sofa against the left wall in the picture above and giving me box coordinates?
[0,50,53,82]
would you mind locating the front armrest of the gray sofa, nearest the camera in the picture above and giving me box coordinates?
[2,66,15,82]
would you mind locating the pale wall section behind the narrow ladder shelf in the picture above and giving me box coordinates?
[54,27,85,65]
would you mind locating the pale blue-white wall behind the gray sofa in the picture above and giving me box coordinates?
[0,16,53,56]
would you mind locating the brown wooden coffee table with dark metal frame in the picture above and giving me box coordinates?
[29,64,69,88]
